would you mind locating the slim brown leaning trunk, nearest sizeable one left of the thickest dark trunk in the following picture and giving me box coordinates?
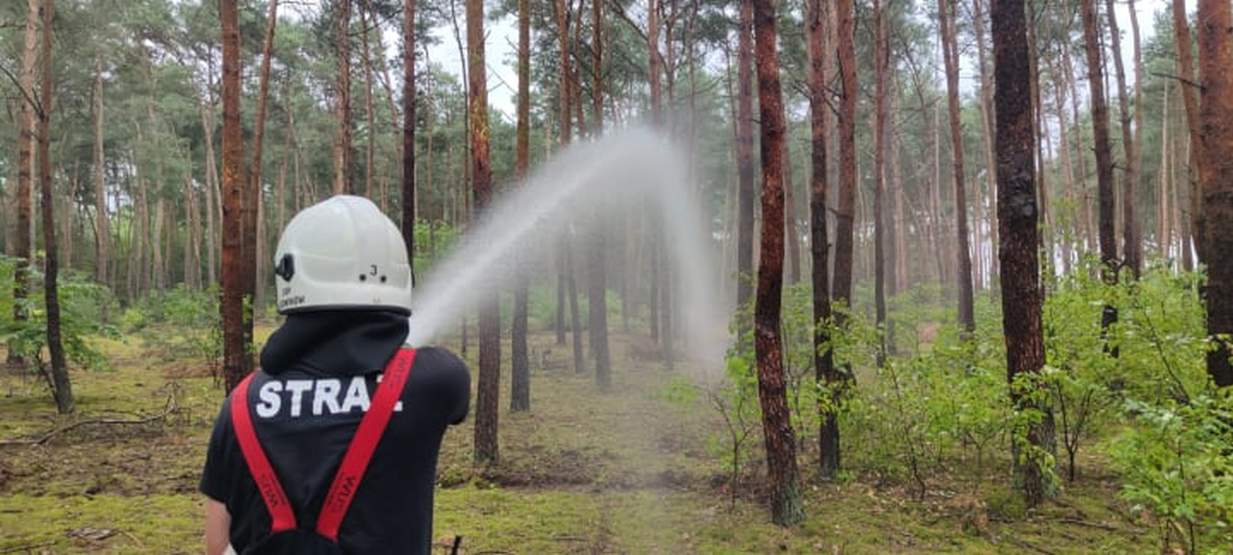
[937,0,979,337]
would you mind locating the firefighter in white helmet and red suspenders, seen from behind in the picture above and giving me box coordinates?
[201,195,470,555]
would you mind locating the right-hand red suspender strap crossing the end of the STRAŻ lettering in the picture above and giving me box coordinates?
[317,349,416,541]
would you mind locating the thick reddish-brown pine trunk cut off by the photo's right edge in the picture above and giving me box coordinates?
[1193,0,1233,387]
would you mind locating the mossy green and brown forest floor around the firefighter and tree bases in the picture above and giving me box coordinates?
[0,329,1158,554]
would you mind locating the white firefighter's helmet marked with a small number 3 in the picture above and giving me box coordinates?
[274,195,412,315]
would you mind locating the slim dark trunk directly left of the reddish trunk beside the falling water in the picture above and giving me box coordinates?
[729,0,753,307]
